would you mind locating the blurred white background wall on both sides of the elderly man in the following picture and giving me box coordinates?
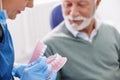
[7,0,120,63]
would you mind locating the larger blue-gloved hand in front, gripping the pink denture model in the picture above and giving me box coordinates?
[20,57,56,80]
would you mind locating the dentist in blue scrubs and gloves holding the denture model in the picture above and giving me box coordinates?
[0,0,56,80]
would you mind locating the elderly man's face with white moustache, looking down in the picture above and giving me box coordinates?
[62,0,100,30]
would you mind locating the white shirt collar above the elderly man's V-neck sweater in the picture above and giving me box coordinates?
[66,18,101,42]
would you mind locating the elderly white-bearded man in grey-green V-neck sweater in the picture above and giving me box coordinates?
[43,0,120,80]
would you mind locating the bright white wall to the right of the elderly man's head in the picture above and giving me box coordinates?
[98,0,120,31]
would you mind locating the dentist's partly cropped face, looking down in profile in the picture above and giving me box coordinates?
[2,0,33,19]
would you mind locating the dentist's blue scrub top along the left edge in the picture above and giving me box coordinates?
[0,11,14,80]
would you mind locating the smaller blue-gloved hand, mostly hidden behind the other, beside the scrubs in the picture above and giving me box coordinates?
[12,64,27,78]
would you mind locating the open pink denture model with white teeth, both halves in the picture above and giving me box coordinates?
[29,42,67,77]
